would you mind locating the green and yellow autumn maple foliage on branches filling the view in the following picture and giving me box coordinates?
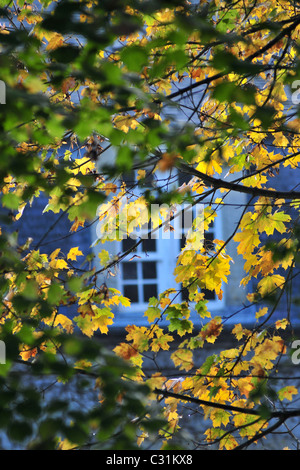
[0,0,300,449]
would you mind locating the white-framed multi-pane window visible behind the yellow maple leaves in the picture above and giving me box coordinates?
[118,169,221,312]
